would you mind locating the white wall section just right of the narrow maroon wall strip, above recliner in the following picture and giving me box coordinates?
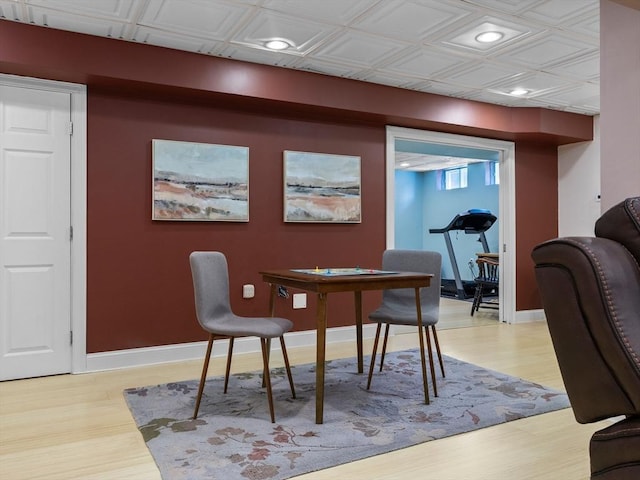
[558,116,601,237]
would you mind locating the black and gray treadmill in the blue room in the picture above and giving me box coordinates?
[429,208,497,299]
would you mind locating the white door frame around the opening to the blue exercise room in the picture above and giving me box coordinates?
[386,126,516,323]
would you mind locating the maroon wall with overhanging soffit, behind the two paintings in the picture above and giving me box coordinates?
[0,20,593,353]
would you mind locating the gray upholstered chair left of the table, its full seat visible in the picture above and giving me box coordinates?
[189,252,296,422]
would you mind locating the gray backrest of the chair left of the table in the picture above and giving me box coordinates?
[189,252,232,327]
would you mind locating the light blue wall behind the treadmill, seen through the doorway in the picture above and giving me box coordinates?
[395,162,499,280]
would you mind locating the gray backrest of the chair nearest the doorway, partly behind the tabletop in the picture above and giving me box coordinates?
[382,250,442,319]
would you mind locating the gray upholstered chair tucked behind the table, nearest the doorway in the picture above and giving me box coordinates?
[367,250,444,403]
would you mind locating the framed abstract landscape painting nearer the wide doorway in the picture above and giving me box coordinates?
[284,150,361,223]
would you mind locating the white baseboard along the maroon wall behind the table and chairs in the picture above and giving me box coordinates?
[80,324,376,373]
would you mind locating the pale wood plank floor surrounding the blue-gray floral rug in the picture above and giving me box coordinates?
[0,302,606,480]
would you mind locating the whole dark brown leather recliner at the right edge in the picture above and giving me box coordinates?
[532,197,640,480]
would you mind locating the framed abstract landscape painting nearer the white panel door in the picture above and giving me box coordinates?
[152,139,249,222]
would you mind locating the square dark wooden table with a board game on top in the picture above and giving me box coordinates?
[259,268,433,424]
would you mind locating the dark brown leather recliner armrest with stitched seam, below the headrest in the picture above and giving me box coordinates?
[532,237,640,423]
